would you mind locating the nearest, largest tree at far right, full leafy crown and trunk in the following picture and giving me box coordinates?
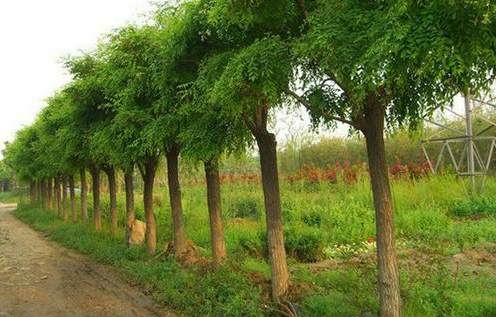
[288,1,495,316]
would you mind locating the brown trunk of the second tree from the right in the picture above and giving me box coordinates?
[255,131,289,301]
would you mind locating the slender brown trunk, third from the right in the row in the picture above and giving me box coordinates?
[205,160,227,265]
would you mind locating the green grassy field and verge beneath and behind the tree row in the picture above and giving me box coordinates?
[4,176,496,317]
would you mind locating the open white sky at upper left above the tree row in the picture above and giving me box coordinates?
[0,0,152,157]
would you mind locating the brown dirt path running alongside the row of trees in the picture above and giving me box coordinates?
[0,204,175,317]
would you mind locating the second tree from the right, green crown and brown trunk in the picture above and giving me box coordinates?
[200,0,302,301]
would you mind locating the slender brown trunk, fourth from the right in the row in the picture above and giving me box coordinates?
[166,145,186,256]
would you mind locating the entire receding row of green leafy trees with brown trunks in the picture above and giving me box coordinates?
[1,0,496,317]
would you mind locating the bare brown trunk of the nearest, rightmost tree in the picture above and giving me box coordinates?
[363,102,401,317]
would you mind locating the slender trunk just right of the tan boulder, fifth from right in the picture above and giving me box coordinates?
[143,158,157,254]
